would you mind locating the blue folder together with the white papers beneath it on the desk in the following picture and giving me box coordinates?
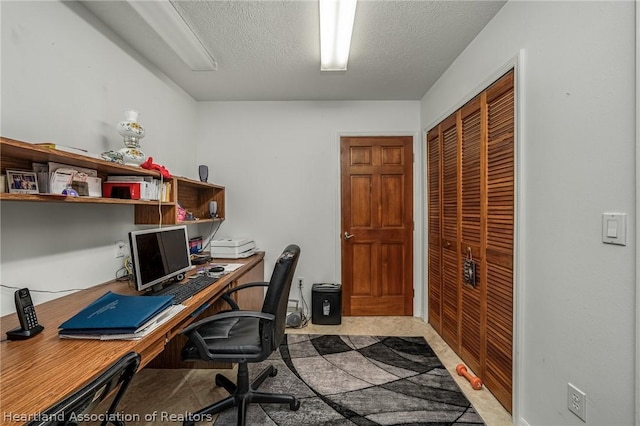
[58,292,184,340]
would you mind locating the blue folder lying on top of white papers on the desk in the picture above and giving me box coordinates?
[59,291,173,334]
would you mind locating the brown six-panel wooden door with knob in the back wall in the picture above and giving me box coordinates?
[340,136,413,316]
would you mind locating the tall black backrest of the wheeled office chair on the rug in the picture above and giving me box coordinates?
[262,244,300,349]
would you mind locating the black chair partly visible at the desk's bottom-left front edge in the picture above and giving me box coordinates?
[28,352,140,426]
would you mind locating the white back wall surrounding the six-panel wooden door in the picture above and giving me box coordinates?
[198,101,423,315]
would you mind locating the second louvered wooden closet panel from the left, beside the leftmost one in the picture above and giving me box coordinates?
[440,114,460,349]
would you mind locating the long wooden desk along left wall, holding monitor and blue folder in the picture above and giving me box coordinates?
[0,252,264,425]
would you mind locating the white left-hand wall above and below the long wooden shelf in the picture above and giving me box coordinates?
[0,2,197,315]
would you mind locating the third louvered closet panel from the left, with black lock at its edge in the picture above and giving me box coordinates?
[460,97,485,372]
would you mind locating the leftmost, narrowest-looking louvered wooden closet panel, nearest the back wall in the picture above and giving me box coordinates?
[427,128,442,333]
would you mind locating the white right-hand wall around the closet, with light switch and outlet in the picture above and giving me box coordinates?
[421,1,638,425]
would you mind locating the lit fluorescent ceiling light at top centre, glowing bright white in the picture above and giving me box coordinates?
[319,0,357,71]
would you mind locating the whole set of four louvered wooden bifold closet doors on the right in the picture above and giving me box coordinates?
[427,71,515,411]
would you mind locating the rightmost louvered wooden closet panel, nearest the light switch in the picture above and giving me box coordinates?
[483,72,514,411]
